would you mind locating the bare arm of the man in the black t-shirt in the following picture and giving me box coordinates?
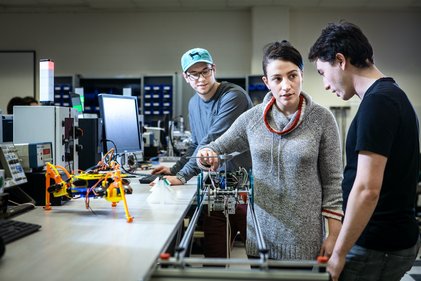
[327,151,387,281]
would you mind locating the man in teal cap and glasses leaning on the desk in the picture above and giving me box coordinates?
[152,48,253,257]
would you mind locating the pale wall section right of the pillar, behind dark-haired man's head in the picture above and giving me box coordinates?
[290,10,421,109]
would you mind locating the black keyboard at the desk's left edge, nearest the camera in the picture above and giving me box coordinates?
[0,219,41,244]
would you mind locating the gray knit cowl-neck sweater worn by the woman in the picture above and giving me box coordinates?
[202,92,342,260]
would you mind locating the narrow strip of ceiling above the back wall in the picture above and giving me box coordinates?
[0,0,421,13]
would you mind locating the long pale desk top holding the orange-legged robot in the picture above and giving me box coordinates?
[0,178,196,281]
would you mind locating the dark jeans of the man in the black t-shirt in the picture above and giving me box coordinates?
[339,236,420,281]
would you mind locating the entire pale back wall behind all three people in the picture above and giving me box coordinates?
[0,9,421,123]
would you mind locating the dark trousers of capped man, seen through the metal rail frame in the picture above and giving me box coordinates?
[203,204,247,258]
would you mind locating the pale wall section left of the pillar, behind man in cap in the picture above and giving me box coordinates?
[0,11,251,114]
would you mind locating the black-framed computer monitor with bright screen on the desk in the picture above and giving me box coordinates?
[98,94,142,155]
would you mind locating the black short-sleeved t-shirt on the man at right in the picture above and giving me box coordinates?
[342,78,419,251]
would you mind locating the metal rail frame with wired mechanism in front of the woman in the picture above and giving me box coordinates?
[151,155,330,281]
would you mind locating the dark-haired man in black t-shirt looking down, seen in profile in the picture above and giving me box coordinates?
[309,22,420,281]
